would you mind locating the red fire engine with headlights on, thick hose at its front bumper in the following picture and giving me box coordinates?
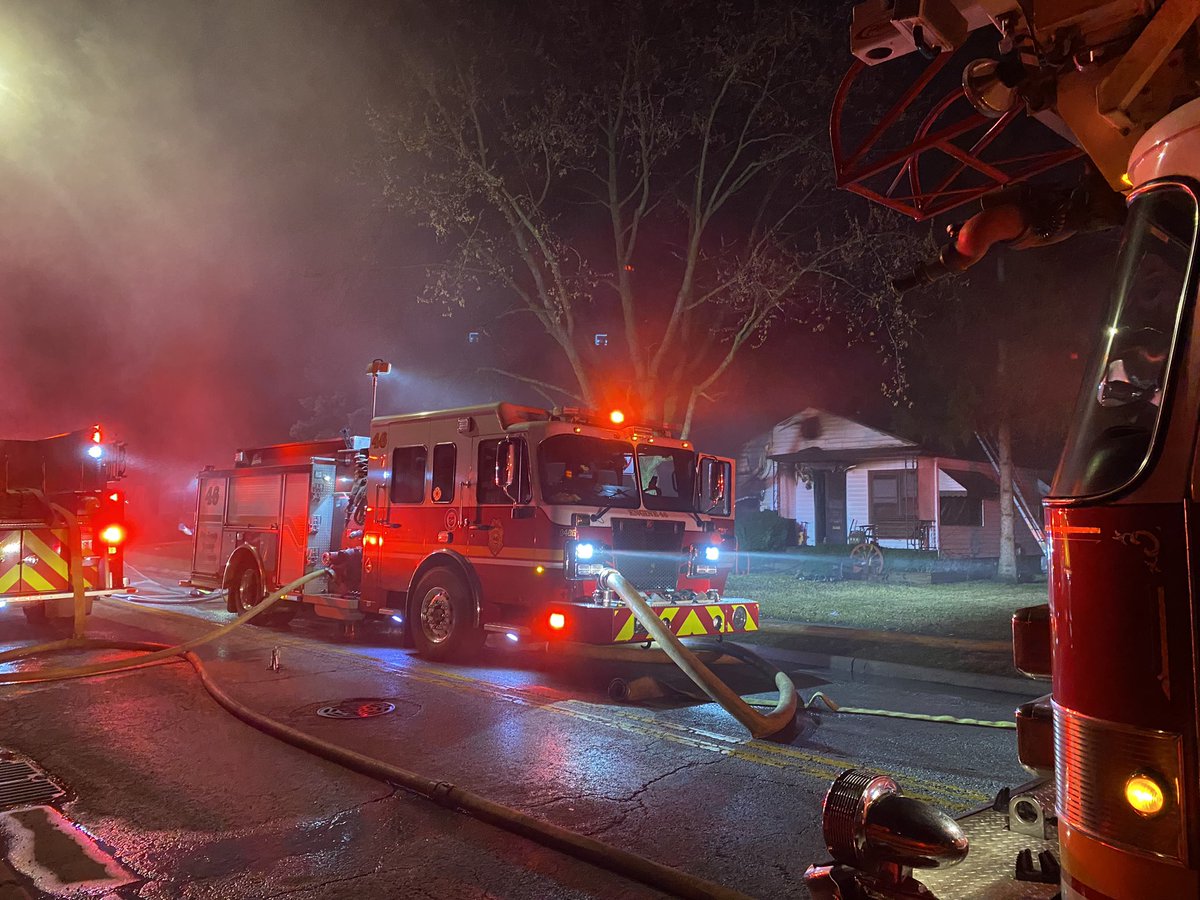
[191,403,758,658]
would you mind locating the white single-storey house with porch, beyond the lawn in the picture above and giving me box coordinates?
[738,408,1049,558]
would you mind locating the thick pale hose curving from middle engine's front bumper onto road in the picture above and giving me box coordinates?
[598,569,796,738]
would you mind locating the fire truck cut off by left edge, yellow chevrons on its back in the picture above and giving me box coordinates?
[0,425,127,622]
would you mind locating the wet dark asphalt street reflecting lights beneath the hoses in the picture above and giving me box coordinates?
[0,560,1036,898]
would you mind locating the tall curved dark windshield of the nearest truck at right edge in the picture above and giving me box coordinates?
[1052,184,1196,497]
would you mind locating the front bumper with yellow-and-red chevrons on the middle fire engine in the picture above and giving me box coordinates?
[535,599,758,644]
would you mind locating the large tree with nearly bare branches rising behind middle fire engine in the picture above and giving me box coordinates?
[373,0,912,434]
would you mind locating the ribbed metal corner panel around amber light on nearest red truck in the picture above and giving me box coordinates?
[1054,703,1187,860]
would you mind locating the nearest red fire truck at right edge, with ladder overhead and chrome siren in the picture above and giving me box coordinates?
[806,0,1200,900]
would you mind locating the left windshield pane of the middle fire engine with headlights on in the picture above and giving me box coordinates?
[538,434,640,509]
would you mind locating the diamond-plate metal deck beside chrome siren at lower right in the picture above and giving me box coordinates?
[913,781,1062,900]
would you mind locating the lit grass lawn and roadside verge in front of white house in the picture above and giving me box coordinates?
[726,572,1046,676]
